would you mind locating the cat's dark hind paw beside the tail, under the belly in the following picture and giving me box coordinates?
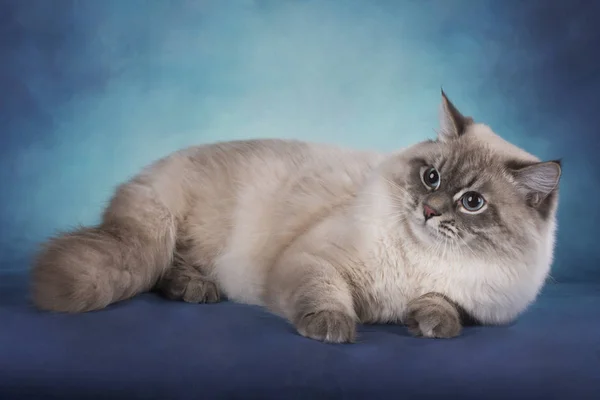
[157,267,221,303]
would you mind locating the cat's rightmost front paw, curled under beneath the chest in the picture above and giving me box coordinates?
[404,292,462,338]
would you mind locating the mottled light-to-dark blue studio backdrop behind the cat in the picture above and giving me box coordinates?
[0,0,600,282]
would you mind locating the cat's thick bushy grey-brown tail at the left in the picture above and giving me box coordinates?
[31,162,184,313]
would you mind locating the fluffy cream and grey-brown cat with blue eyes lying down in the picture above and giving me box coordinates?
[31,90,562,343]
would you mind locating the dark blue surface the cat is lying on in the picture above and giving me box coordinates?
[0,276,600,400]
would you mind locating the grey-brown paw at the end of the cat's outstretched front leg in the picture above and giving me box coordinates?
[296,310,356,343]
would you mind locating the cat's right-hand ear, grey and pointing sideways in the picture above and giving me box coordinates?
[511,160,562,207]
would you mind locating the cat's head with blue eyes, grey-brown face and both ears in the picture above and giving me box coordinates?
[388,92,561,258]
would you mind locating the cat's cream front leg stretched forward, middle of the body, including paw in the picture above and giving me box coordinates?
[266,253,357,343]
